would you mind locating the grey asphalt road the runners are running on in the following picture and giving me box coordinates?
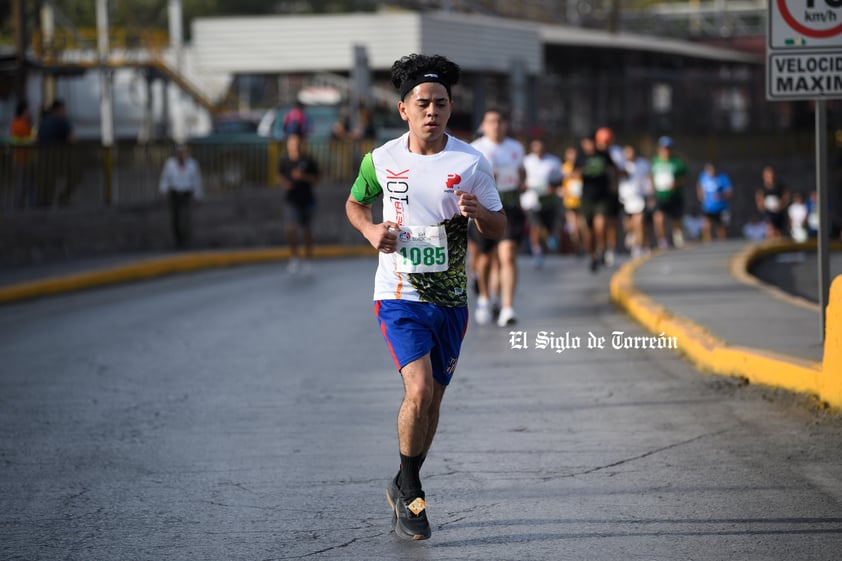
[0,258,842,561]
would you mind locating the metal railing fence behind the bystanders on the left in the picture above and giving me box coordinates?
[0,141,372,211]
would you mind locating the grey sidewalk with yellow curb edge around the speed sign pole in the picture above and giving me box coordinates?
[611,241,842,409]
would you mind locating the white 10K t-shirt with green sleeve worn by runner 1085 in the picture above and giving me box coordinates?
[351,133,503,306]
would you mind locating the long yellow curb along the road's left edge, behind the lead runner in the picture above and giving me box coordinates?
[0,245,376,304]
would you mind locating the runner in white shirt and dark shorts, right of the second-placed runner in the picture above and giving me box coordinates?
[520,138,563,268]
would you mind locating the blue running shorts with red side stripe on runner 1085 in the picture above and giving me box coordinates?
[374,300,468,386]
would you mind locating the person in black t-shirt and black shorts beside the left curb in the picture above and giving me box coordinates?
[278,134,319,273]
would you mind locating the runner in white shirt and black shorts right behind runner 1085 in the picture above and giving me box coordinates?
[472,109,526,327]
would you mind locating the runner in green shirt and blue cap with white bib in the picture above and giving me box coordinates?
[652,136,687,249]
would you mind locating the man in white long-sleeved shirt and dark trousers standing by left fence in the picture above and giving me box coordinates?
[158,145,204,249]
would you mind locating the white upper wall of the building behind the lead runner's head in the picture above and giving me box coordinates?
[192,12,543,73]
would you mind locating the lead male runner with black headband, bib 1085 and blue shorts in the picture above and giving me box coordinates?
[345,54,506,540]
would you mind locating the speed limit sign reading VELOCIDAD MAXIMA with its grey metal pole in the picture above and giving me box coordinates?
[766,0,842,341]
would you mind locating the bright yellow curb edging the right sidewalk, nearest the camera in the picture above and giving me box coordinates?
[611,247,842,409]
